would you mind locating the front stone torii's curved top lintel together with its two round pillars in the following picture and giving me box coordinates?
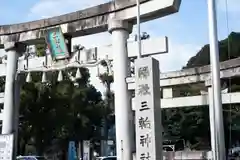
[0,0,181,160]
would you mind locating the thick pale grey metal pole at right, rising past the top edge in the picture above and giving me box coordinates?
[208,0,226,160]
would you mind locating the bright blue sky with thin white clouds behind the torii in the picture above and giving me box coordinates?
[0,0,240,92]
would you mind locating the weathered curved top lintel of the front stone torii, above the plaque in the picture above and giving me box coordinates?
[0,0,181,48]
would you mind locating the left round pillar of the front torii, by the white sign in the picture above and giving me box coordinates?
[2,42,26,159]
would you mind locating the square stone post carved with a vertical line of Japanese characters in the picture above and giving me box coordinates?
[135,57,163,160]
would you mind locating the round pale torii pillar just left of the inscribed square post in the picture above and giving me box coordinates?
[108,19,134,160]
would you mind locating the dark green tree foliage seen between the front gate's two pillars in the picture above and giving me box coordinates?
[16,68,107,154]
